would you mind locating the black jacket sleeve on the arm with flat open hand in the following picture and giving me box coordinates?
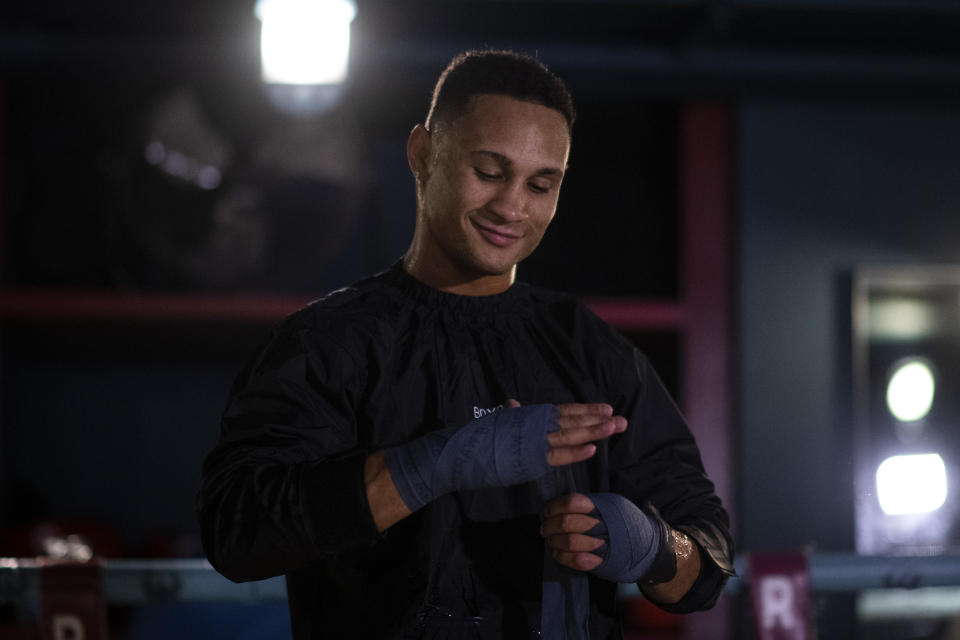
[197,322,378,581]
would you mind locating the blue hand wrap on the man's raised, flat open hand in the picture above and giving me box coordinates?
[384,404,560,511]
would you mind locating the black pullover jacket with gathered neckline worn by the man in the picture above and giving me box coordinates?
[198,263,732,640]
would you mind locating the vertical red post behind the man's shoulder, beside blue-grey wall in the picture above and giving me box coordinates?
[678,101,736,638]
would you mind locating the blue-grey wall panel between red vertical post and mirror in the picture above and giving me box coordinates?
[738,100,960,550]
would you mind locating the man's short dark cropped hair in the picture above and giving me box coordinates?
[426,50,576,130]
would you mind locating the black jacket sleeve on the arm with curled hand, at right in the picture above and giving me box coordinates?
[610,347,734,613]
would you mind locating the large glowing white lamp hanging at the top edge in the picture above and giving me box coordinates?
[256,0,357,85]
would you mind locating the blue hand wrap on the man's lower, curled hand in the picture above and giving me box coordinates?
[587,493,677,584]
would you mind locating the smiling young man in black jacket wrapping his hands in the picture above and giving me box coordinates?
[198,47,732,639]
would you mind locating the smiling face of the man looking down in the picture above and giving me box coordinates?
[417,94,570,282]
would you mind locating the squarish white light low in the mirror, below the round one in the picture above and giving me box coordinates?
[877,453,947,515]
